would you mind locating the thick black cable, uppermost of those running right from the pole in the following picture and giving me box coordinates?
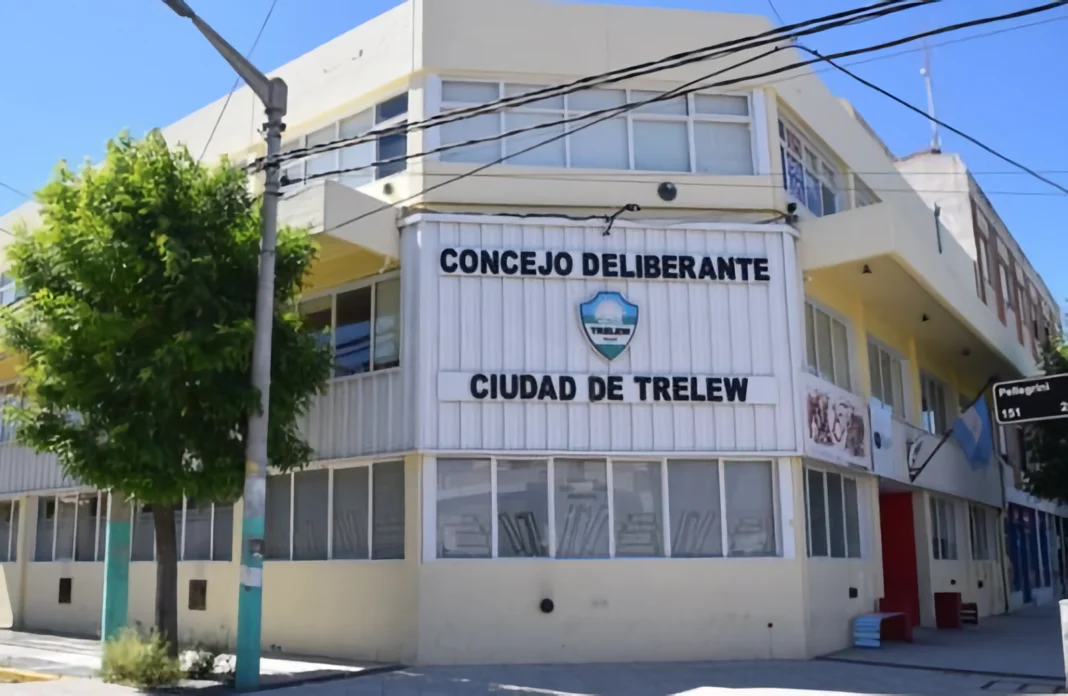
[258,0,927,169]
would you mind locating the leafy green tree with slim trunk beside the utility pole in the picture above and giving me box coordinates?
[0,132,330,652]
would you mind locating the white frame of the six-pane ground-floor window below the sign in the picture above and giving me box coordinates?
[422,453,785,563]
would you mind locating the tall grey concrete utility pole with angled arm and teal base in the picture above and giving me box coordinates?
[163,0,287,691]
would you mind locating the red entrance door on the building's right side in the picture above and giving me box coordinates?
[879,493,920,626]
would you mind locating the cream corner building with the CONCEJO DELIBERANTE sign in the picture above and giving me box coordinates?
[0,0,1055,663]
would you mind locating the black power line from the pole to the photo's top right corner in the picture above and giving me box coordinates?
[286,0,1061,187]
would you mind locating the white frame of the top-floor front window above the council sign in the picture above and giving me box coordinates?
[437,80,759,176]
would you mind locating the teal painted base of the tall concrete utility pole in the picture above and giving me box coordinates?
[234,517,264,691]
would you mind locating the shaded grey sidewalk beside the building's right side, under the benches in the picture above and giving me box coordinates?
[822,603,1065,683]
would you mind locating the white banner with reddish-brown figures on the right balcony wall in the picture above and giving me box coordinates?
[802,373,871,469]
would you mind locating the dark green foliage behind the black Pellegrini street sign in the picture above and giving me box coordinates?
[1023,339,1068,503]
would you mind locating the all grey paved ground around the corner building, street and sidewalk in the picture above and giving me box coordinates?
[0,605,1064,696]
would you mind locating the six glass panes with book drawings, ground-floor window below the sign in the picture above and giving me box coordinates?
[435,458,777,558]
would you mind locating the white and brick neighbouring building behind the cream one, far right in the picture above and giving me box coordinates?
[897,152,1068,607]
